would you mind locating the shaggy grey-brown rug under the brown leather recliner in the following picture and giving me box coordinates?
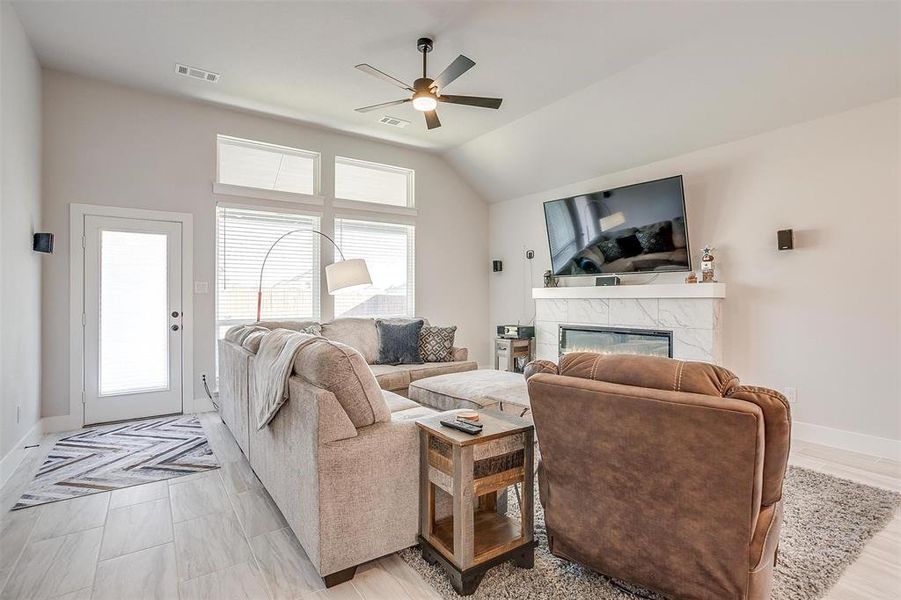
[400,467,901,600]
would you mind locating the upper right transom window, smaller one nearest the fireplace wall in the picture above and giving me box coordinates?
[335,156,413,207]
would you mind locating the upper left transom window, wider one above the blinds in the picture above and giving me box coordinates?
[217,135,319,196]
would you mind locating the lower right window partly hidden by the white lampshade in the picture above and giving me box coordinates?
[334,218,415,317]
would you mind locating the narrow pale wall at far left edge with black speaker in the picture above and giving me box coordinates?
[0,2,41,457]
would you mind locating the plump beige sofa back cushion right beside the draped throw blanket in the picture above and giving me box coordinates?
[294,338,391,428]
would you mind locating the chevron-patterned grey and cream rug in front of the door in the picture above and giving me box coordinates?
[12,416,219,510]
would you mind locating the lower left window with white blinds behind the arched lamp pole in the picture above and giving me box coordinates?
[216,206,320,346]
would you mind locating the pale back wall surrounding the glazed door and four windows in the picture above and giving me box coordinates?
[43,70,489,416]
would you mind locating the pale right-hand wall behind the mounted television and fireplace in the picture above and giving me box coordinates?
[490,98,901,440]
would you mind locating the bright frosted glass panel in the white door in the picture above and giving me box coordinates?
[100,231,169,396]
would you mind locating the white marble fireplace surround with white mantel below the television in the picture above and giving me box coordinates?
[532,283,726,364]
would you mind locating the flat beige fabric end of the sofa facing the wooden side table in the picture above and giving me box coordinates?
[317,420,419,575]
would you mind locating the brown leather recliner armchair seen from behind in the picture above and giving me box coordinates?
[526,352,791,600]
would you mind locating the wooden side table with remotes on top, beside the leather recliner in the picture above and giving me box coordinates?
[417,411,537,596]
